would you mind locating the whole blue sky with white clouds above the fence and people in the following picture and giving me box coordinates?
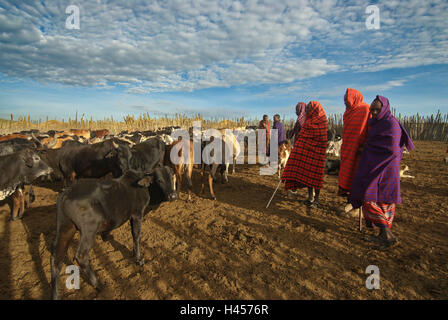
[0,0,448,119]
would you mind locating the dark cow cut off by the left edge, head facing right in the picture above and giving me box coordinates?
[0,149,52,220]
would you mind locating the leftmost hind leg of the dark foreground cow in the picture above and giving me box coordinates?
[50,222,76,300]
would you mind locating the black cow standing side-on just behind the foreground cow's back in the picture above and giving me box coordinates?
[59,139,122,186]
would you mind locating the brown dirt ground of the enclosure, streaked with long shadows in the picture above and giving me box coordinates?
[0,142,448,299]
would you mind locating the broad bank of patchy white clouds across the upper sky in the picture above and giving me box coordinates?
[0,0,448,93]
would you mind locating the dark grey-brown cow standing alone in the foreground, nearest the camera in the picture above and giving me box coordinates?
[50,167,177,299]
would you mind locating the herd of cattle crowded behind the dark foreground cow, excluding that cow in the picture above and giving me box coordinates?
[0,126,342,220]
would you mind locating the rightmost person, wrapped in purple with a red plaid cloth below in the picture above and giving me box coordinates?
[349,96,414,248]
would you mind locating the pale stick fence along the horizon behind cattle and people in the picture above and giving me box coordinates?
[0,111,448,142]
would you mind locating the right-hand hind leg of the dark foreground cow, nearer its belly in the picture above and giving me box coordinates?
[75,227,101,289]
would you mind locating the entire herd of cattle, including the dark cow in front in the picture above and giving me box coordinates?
[0,127,346,298]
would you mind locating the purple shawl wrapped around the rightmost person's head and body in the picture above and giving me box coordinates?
[349,96,414,208]
